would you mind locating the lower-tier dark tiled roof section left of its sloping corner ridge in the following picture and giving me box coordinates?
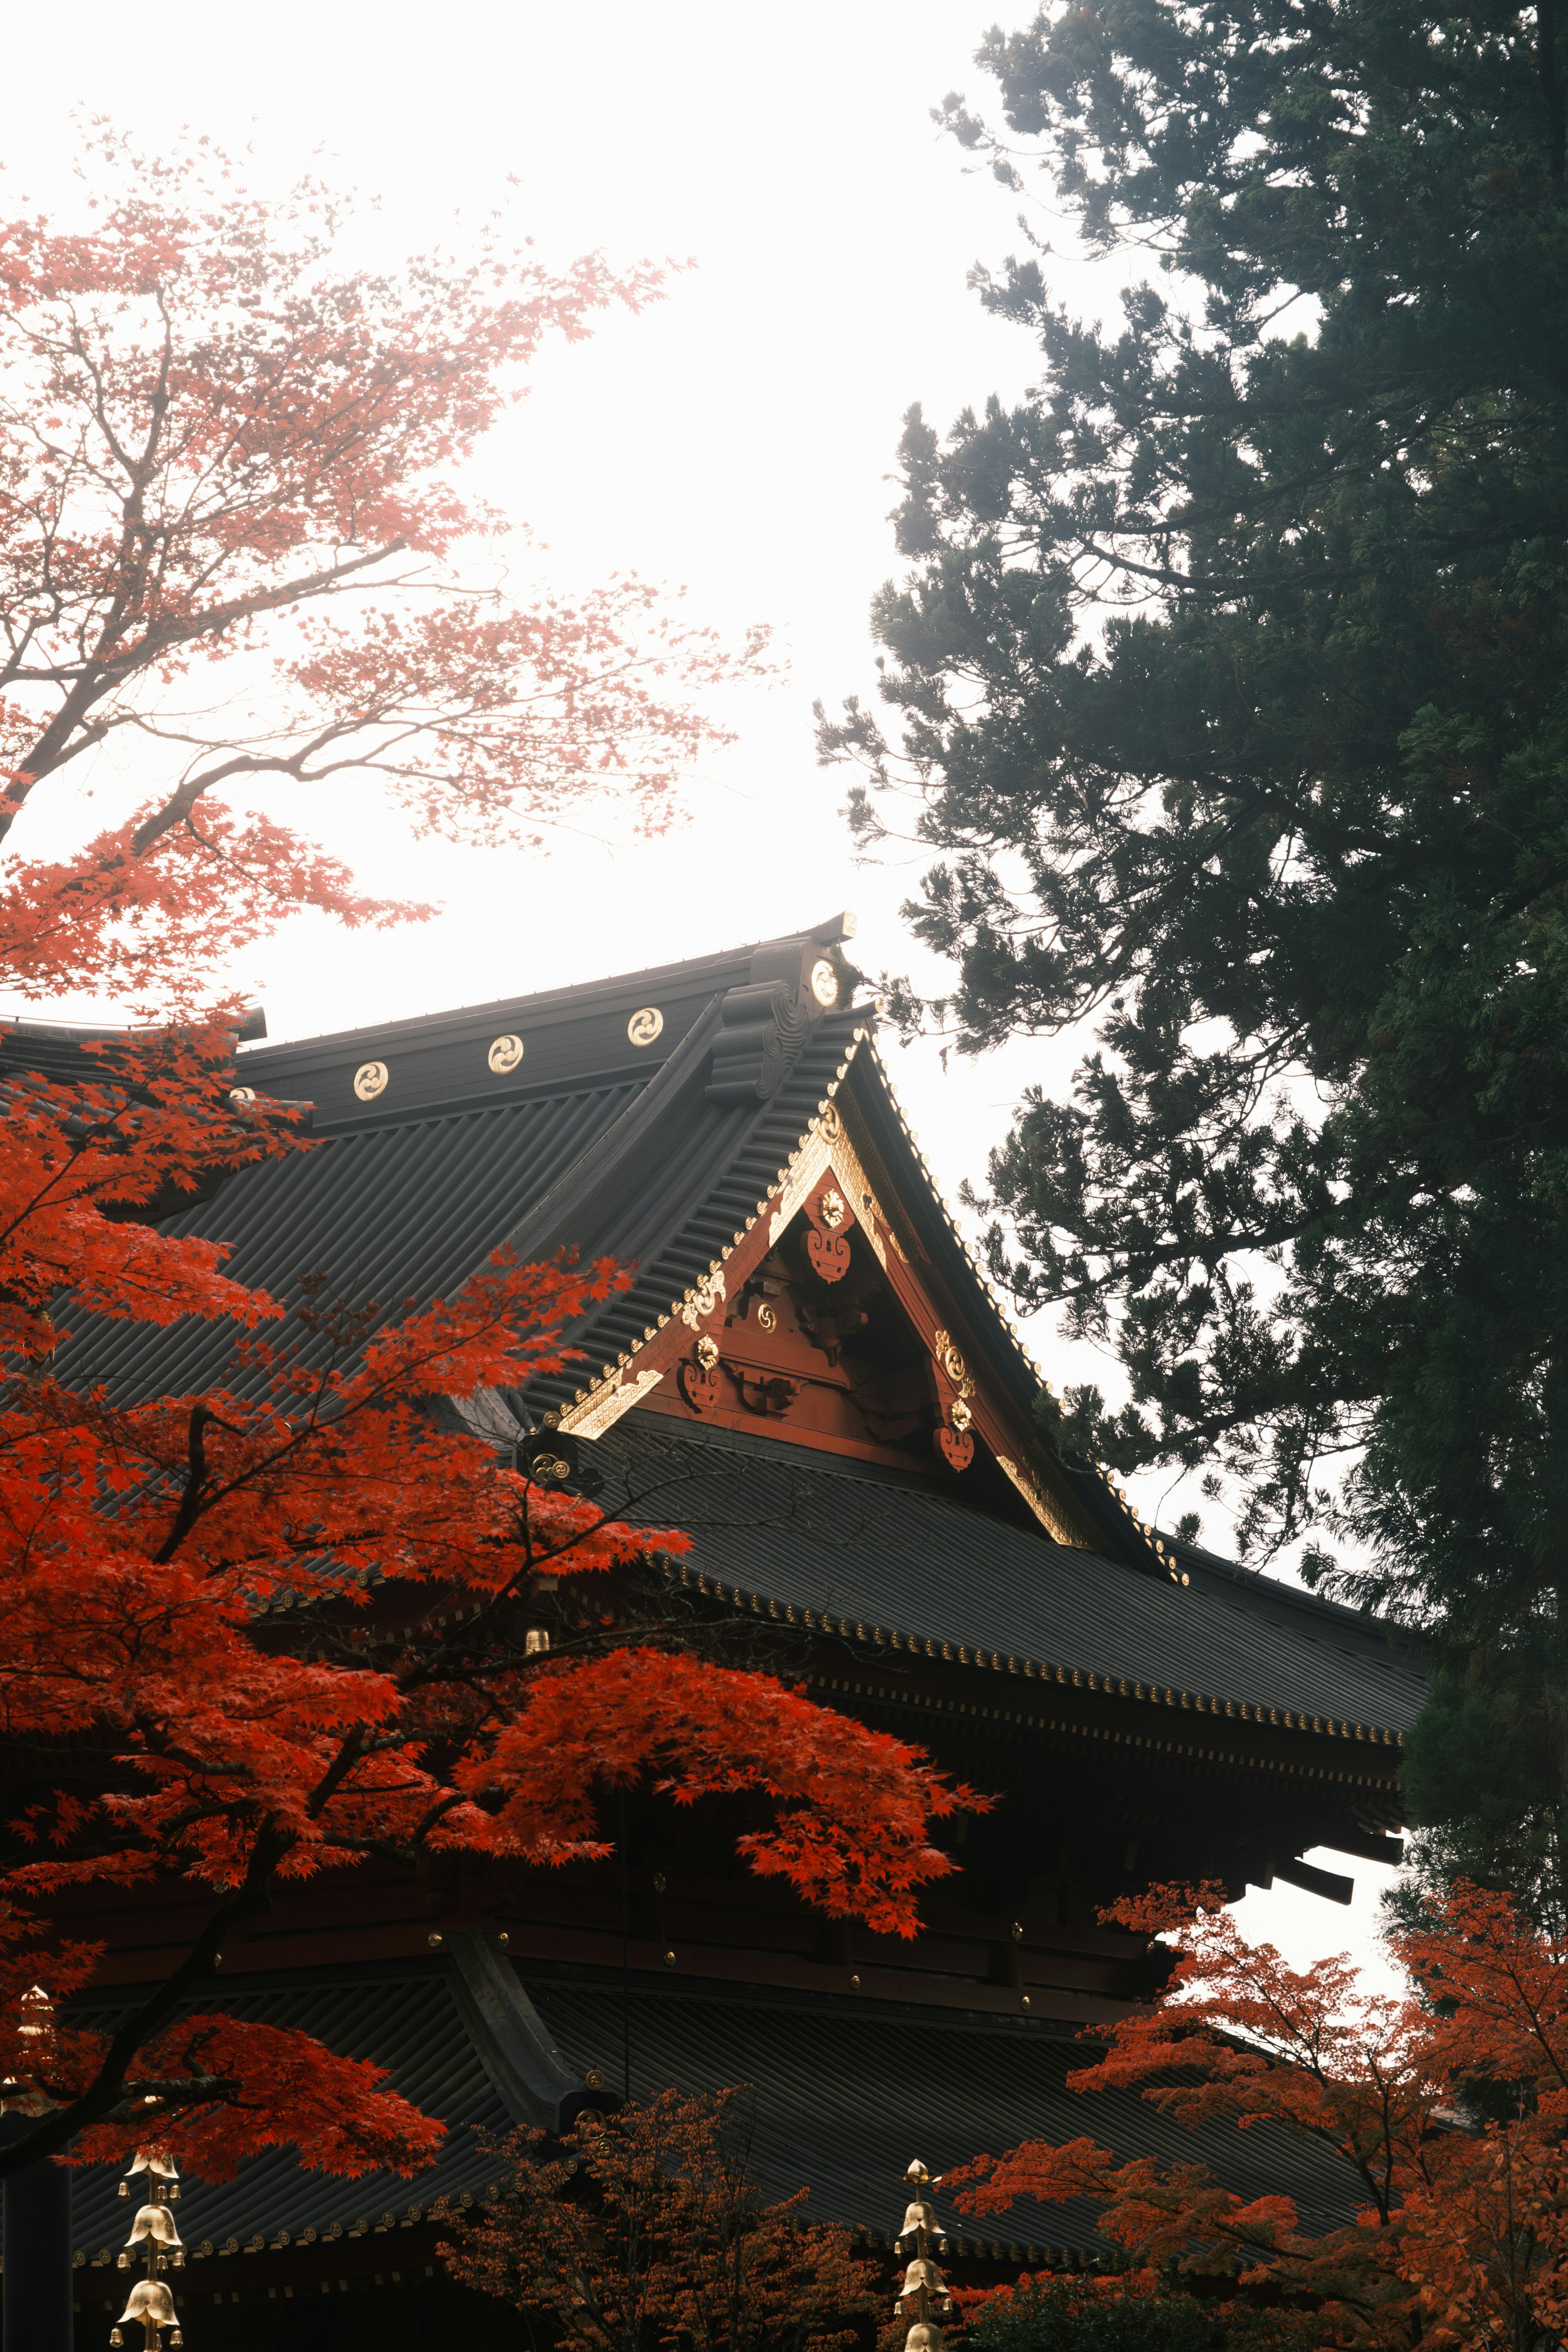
[73,1966,512,2263]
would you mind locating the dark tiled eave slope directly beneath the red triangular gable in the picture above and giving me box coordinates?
[602,1414,1425,1731]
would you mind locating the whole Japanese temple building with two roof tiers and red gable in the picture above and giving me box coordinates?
[18,917,1422,2352]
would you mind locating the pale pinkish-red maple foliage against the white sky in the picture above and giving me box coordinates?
[0,125,766,1007]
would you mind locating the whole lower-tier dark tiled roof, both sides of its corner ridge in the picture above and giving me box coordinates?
[73,1936,1359,2258]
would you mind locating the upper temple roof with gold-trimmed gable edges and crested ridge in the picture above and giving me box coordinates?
[46,917,1422,1748]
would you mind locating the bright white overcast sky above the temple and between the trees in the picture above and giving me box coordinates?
[0,0,1380,1985]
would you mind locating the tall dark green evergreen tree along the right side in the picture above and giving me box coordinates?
[823,0,1568,1835]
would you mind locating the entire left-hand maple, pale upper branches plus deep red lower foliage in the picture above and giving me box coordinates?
[0,141,966,2178]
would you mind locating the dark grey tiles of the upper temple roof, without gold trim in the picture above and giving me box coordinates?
[46,927,1422,1731]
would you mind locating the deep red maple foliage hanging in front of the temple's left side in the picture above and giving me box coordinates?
[0,1068,964,2178]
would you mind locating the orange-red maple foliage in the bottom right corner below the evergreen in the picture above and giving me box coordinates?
[952,1886,1568,2352]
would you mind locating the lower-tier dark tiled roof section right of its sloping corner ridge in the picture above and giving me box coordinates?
[529,1980,1361,2246]
